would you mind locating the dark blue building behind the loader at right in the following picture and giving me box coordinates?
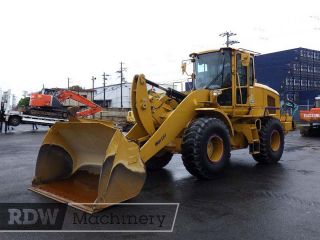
[255,48,320,105]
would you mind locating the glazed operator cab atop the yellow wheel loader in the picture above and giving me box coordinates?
[190,48,255,106]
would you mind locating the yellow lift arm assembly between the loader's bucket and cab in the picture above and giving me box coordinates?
[127,74,210,162]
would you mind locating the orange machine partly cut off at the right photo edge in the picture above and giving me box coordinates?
[300,96,320,136]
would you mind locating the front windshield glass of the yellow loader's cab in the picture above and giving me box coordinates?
[195,51,231,89]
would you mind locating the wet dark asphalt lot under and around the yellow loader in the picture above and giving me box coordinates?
[0,127,320,240]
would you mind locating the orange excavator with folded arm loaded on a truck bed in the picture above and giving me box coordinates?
[26,89,102,119]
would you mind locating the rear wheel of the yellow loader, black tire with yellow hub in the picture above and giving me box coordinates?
[252,118,284,164]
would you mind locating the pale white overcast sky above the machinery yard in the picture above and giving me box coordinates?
[0,0,320,95]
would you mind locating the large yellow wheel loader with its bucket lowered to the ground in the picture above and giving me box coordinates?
[30,48,292,213]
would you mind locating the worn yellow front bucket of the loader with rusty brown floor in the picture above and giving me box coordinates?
[29,120,146,213]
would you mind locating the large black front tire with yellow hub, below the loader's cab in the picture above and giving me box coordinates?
[182,118,230,179]
